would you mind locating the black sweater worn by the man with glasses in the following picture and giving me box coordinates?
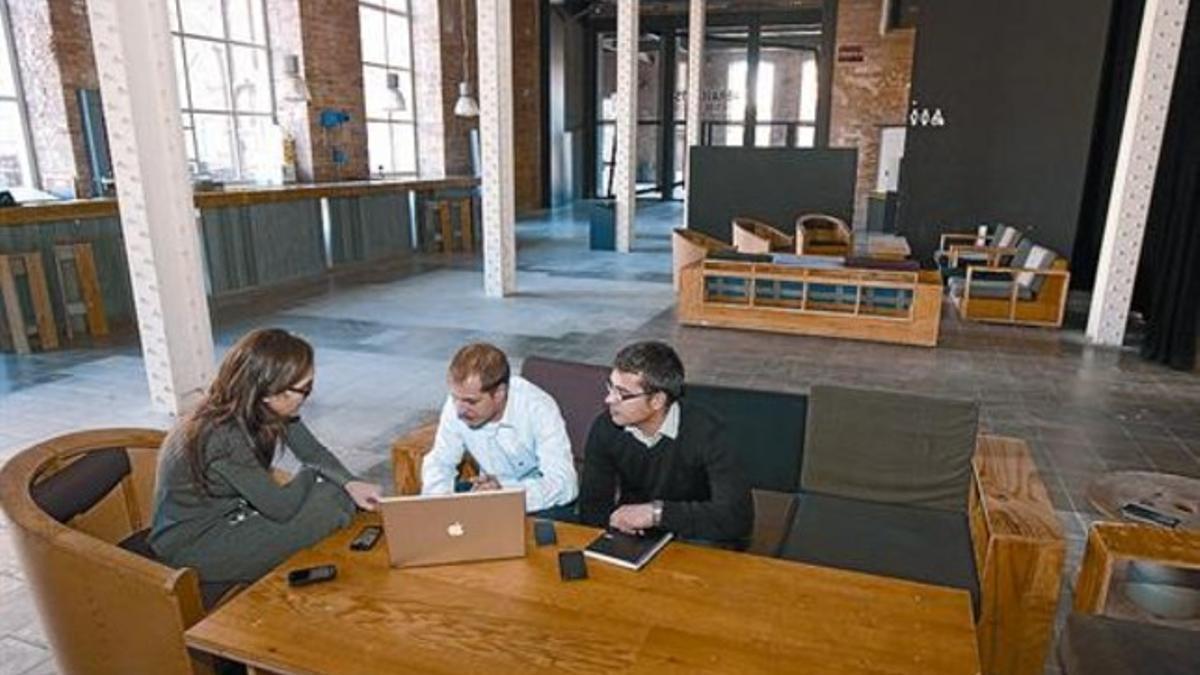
[580,400,754,542]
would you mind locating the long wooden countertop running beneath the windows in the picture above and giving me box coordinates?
[0,175,479,227]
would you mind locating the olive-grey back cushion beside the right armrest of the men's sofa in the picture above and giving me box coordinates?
[800,384,979,512]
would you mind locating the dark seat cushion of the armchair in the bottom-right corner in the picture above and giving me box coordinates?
[1058,614,1200,675]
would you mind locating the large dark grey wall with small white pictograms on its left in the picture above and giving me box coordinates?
[899,0,1111,258]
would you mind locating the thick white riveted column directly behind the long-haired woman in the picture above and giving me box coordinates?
[88,0,214,414]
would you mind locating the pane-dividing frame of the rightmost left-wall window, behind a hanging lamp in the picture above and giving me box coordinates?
[355,0,421,178]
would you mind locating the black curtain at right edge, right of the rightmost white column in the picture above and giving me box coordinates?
[1134,1,1200,370]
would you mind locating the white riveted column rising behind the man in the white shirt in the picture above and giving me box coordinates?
[475,0,517,298]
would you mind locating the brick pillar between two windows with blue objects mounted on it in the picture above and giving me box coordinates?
[299,0,371,183]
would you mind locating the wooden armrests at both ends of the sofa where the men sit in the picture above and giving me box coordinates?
[391,422,1066,675]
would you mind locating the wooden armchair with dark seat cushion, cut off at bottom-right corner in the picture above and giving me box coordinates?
[1058,522,1200,675]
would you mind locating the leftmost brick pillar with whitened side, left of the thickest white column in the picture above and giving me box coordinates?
[8,0,100,197]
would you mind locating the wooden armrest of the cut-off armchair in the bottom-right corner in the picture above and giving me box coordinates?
[1075,522,1200,614]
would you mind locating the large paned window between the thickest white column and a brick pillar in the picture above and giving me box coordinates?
[167,0,276,180]
